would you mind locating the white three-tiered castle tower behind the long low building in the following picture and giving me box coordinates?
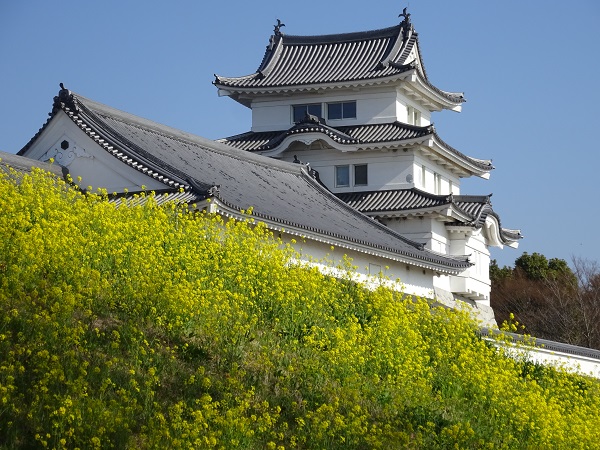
[214,13,521,316]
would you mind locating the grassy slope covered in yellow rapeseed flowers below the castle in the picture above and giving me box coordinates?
[0,167,600,450]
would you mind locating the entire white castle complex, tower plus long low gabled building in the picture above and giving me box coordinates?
[14,10,521,325]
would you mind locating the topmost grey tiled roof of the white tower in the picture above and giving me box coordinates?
[214,22,464,104]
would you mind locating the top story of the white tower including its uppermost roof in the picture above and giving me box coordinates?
[214,11,464,132]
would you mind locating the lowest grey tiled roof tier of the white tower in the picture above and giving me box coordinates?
[336,188,523,243]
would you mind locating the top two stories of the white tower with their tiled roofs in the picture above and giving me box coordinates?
[214,9,493,194]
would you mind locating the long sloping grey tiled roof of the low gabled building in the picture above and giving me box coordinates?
[21,89,470,273]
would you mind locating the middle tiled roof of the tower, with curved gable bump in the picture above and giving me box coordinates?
[219,121,494,171]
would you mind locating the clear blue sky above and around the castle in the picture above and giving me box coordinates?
[0,0,600,265]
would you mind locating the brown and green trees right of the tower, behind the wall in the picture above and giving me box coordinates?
[490,253,600,349]
